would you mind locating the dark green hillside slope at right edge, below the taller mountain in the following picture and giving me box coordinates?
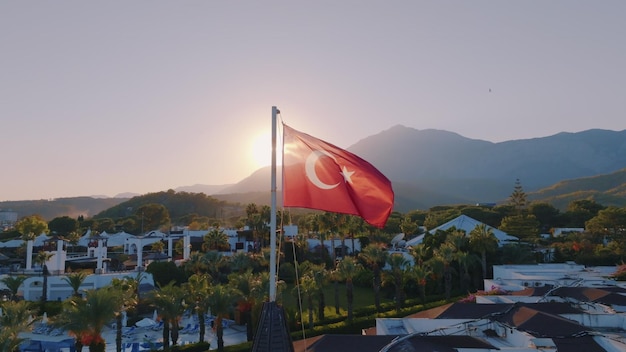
[528,168,626,209]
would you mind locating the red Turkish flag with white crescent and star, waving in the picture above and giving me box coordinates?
[283,124,394,228]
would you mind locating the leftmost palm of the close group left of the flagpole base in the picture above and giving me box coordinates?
[148,281,187,351]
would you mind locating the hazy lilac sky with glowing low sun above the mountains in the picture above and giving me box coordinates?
[0,0,626,200]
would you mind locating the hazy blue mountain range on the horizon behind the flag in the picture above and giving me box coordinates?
[0,125,626,220]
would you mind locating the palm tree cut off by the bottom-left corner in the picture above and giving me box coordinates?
[0,301,33,352]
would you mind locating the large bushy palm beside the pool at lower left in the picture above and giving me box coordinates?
[59,286,123,352]
